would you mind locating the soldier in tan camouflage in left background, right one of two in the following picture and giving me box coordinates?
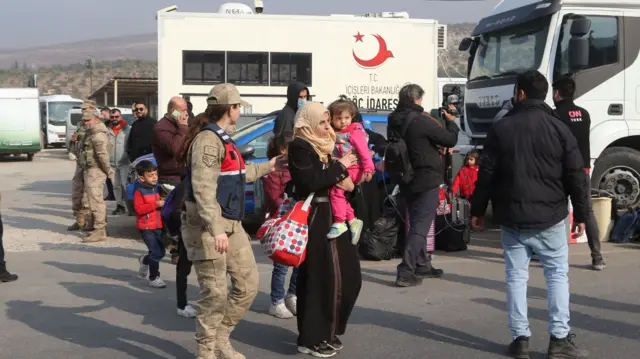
[80,110,111,243]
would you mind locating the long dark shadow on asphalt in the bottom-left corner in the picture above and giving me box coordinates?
[6,300,194,359]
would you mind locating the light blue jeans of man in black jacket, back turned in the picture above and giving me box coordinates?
[500,220,569,338]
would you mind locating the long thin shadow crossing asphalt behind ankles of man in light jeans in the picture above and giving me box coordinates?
[471,295,640,340]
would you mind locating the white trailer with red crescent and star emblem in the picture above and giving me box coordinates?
[157,6,446,113]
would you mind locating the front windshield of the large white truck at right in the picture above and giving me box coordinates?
[469,16,551,81]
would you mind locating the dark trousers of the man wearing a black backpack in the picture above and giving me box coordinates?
[398,188,439,276]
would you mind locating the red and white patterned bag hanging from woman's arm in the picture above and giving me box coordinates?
[256,193,313,267]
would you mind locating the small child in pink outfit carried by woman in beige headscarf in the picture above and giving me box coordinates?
[327,99,375,245]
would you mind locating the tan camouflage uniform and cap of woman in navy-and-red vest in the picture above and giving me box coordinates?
[182,84,271,359]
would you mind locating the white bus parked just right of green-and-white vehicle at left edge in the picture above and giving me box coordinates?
[40,95,83,148]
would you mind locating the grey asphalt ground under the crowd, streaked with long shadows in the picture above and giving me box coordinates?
[0,151,640,359]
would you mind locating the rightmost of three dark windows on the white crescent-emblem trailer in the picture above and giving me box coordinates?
[271,52,312,86]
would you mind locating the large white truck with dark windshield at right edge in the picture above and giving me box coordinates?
[460,0,640,207]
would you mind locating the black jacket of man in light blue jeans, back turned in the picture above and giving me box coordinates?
[471,100,588,229]
